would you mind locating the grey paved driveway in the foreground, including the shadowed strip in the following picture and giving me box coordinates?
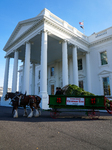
[0,107,112,150]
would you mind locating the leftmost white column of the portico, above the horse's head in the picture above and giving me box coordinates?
[3,57,10,96]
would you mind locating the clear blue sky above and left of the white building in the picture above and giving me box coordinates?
[0,0,112,88]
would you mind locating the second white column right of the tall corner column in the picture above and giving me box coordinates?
[73,46,78,86]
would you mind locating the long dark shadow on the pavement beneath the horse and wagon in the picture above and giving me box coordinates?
[0,106,112,122]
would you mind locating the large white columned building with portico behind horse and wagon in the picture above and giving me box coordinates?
[2,9,112,109]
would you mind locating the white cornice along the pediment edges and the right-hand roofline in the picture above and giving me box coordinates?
[3,12,112,51]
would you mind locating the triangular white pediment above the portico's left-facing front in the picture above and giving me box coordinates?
[4,16,42,50]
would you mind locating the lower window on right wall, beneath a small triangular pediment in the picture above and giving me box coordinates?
[103,77,110,95]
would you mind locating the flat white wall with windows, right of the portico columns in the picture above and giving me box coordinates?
[90,42,112,95]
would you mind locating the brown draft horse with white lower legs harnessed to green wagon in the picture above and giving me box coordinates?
[5,92,41,118]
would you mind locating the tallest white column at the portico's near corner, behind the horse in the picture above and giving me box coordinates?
[40,31,48,109]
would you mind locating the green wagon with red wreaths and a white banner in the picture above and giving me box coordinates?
[49,95,112,119]
